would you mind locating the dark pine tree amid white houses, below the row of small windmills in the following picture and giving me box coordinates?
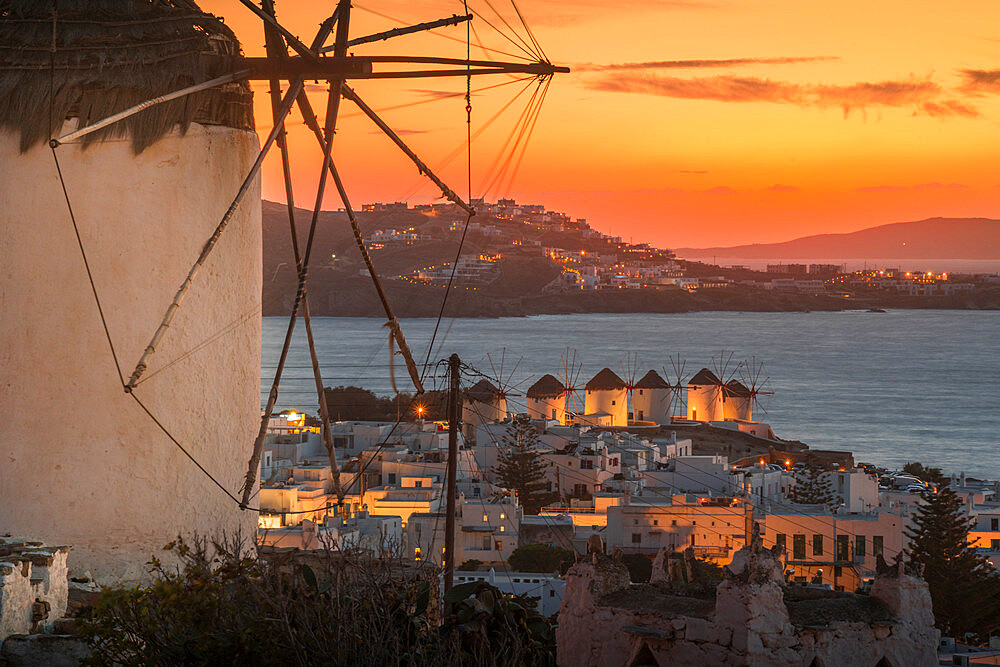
[493,419,554,514]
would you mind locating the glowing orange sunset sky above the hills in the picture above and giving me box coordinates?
[201,0,1000,247]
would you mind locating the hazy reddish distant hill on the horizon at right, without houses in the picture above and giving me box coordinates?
[675,218,1000,260]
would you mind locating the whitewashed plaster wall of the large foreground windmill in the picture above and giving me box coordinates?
[0,121,261,582]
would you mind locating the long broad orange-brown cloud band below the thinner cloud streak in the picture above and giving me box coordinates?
[589,73,979,118]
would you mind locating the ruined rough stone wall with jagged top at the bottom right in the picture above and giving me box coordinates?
[556,536,939,667]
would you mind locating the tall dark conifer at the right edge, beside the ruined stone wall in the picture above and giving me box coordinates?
[906,485,1000,640]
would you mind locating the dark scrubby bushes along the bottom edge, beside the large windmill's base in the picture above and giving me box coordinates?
[80,539,554,665]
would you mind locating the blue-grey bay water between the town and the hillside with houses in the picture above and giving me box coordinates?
[261,310,1000,479]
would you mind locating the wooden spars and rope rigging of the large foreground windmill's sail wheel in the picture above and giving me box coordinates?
[41,0,565,511]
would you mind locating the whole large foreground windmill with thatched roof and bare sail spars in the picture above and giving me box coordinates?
[0,0,567,577]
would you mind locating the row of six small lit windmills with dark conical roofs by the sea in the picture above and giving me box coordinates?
[466,355,773,426]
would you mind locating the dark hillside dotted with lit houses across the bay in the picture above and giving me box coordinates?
[263,199,1000,317]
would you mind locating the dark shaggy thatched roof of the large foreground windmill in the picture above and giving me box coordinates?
[0,0,253,152]
